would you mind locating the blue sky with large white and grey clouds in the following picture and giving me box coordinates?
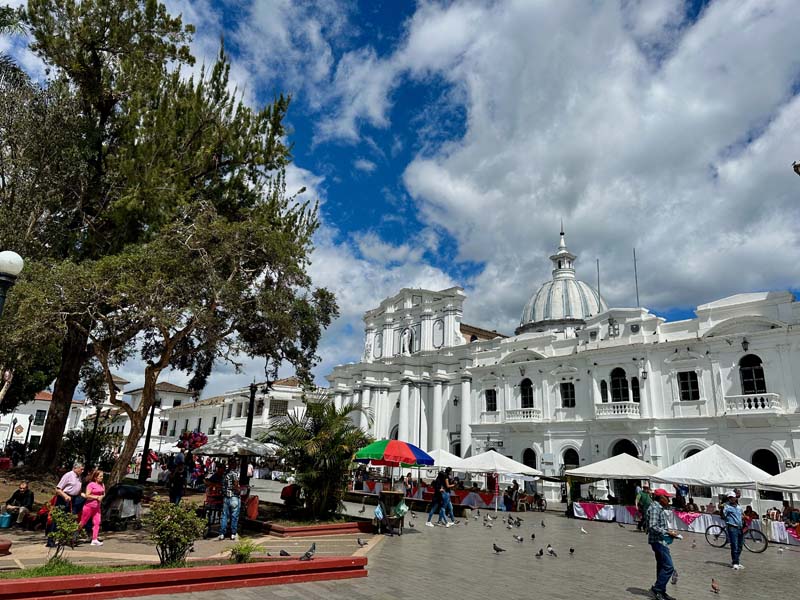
[3,0,800,394]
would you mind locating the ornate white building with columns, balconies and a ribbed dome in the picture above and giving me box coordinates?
[328,233,800,498]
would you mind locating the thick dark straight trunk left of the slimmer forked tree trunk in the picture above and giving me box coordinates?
[34,323,89,472]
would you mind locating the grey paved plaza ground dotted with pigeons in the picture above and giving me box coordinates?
[134,511,800,600]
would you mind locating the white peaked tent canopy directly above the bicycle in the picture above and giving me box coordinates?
[650,444,770,489]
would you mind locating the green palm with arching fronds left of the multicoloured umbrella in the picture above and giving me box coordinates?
[263,393,372,519]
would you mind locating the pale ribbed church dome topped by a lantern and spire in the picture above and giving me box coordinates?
[516,231,608,334]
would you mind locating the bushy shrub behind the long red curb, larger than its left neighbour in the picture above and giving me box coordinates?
[145,499,206,567]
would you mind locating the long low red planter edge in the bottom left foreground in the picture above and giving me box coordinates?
[0,557,367,600]
